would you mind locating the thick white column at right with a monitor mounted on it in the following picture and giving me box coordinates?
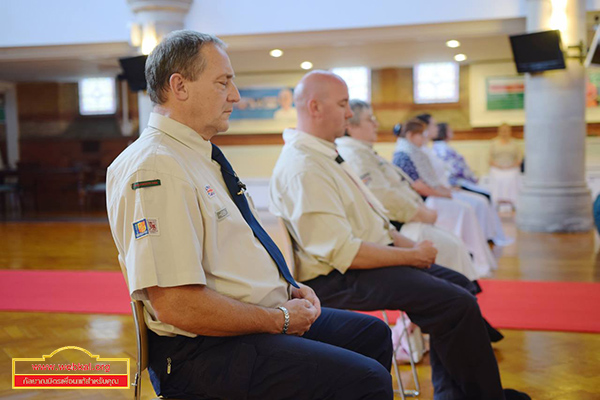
[517,0,592,232]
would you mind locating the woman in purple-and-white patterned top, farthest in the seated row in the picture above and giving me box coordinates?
[432,122,491,200]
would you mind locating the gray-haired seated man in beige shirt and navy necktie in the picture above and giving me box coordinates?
[106,31,393,400]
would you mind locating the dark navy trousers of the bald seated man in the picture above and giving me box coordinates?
[304,265,504,400]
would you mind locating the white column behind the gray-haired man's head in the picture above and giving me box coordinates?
[127,0,193,133]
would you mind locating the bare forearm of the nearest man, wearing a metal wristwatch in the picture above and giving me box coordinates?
[147,285,284,336]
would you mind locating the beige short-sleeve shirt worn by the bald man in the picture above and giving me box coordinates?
[269,129,393,281]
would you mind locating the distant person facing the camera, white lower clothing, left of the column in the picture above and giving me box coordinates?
[490,124,523,209]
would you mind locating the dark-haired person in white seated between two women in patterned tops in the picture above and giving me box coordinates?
[417,114,513,246]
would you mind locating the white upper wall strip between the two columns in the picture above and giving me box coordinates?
[186,0,525,36]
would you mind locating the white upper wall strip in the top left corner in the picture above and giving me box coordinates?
[0,0,133,47]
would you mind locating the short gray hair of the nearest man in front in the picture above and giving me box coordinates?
[146,30,226,104]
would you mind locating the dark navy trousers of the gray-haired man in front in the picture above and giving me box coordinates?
[148,308,393,400]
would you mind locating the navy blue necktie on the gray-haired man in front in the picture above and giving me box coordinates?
[212,144,299,287]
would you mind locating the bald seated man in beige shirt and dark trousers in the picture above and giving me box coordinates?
[270,71,529,400]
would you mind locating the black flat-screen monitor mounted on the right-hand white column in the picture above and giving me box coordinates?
[510,30,566,73]
